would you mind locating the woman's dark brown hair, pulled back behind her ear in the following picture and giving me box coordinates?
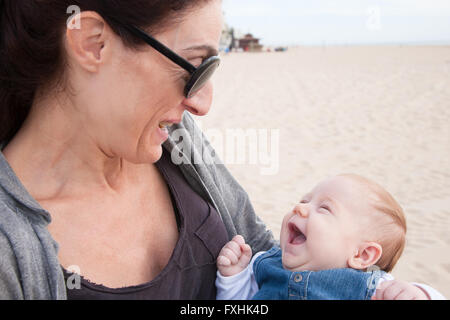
[0,0,208,142]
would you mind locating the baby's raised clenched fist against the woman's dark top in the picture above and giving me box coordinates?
[217,235,252,277]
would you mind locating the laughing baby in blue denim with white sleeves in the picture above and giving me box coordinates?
[216,174,428,300]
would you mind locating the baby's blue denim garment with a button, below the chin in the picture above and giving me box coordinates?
[253,247,384,300]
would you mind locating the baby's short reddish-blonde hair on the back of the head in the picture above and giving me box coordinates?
[339,174,406,272]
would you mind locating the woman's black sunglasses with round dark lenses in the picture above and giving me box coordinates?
[118,25,220,98]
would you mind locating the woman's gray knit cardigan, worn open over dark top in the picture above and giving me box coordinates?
[0,112,276,299]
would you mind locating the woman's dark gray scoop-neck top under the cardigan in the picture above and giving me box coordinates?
[63,150,228,300]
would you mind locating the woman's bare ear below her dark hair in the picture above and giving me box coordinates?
[66,11,107,72]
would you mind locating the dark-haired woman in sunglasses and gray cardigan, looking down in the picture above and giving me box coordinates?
[0,0,442,299]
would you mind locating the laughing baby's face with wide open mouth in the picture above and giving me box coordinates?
[280,176,371,271]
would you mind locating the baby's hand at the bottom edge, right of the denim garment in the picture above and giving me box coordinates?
[372,280,429,300]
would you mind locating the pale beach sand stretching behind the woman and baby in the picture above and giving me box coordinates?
[196,46,450,297]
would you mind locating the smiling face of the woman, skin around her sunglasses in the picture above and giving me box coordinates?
[84,0,223,163]
